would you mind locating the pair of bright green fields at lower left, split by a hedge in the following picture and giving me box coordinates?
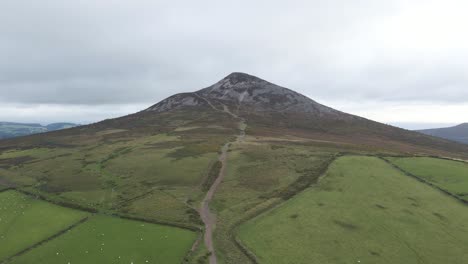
[0,190,197,264]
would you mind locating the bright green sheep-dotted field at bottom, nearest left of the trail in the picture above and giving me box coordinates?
[11,215,196,264]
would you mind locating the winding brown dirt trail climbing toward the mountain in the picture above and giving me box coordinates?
[197,95,247,264]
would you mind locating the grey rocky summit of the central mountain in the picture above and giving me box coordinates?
[147,72,349,119]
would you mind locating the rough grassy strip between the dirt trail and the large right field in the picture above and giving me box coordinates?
[212,137,336,263]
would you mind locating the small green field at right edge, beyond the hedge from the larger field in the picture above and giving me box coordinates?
[386,157,468,201]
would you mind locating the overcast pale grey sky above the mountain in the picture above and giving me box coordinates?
[0,0,468,128]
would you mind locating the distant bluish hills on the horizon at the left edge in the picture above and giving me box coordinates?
[0,122,78,139]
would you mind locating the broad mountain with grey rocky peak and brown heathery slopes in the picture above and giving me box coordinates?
[3,72,467,155]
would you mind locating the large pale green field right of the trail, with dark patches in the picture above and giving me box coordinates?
[238,156,468,264]
